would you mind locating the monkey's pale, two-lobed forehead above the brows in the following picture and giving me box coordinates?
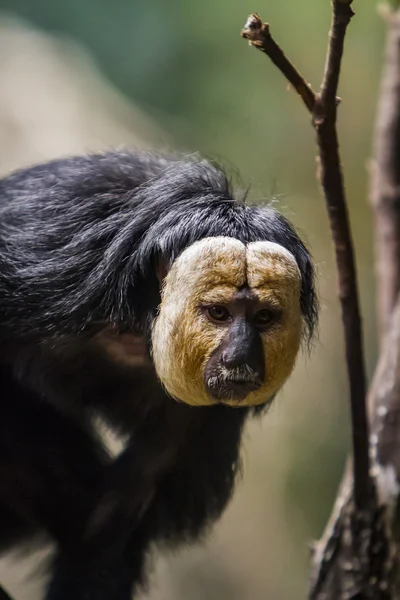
[170,237,301,288]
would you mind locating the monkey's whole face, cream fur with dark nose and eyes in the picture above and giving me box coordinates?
[152,237,302,406]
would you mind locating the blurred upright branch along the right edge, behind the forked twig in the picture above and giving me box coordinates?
[371,10,400,339]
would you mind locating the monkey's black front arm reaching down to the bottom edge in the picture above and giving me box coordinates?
[47,404,189,600]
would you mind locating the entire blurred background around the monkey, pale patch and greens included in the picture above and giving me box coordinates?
[0,0,384,600]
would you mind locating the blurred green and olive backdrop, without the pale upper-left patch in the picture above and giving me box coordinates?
[0,0,384,600]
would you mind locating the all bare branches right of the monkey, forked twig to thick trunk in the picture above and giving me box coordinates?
[244,0,400,600]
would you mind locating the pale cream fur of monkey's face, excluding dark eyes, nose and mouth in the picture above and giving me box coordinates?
[152,237,302,406]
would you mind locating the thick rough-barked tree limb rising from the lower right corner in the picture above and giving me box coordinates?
[309,295,400,600]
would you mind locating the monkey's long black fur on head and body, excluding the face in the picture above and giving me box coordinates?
[0,152,317,600]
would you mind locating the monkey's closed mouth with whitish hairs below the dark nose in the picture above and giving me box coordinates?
[205,373,262,402]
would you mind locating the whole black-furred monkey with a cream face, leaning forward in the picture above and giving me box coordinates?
[0,150,318,600]
